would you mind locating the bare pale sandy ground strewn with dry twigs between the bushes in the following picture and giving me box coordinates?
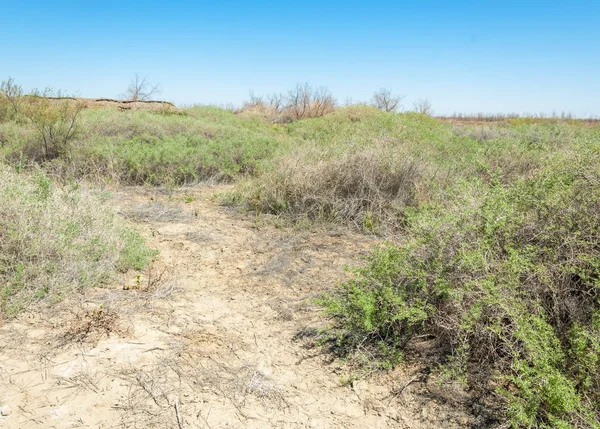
[0,186,479,428]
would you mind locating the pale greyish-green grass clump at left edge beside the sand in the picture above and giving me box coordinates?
[0,164,156,317]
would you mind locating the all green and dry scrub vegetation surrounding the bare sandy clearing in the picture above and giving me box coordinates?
[0,83,600,428]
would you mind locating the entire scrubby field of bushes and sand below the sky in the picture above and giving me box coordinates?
[0,93,600,428]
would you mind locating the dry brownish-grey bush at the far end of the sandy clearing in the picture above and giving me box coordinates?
[243,144,422,230]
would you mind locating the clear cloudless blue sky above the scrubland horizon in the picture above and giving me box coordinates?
[0,0,600,116]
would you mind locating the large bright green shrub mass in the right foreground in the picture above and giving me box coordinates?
[325,146,600,428]
